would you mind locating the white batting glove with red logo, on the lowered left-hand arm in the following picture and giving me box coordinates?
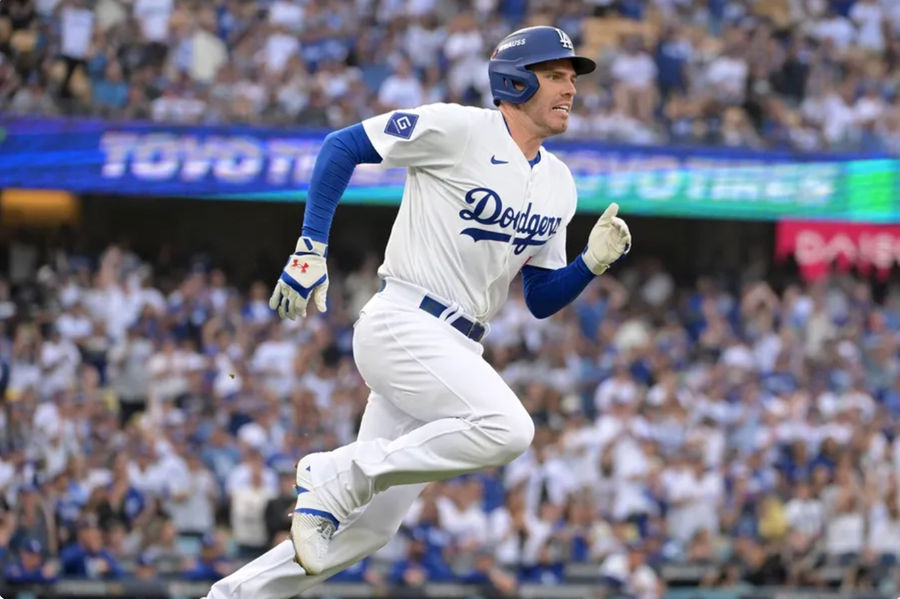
[269,237,328,320]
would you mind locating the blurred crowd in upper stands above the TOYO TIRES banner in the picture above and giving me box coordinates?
[0,0,900,154]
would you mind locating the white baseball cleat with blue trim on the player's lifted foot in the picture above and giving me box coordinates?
[291,456,340,574]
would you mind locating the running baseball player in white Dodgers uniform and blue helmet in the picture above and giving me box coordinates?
[209,27,631,599]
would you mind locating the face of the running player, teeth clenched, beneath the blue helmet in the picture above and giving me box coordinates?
[521,58,577,137]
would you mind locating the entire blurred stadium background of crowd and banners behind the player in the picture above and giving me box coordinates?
[0,0,900,599]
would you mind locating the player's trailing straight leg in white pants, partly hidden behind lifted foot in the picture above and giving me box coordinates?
[207,393,424,599]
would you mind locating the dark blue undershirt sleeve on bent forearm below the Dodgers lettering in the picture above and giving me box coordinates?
[522,254,595,318]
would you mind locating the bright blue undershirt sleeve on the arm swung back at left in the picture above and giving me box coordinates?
[302,123,381,243]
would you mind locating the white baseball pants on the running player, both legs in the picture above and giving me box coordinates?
[208,279,534,599]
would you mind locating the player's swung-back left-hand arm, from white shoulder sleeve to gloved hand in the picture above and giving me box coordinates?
[269,104,469,320]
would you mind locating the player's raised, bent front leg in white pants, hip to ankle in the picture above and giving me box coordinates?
[304,300,534,528]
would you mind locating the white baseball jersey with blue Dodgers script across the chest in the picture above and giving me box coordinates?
[362,104,577,322]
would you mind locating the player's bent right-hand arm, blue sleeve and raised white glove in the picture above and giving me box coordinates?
[522,203,631,318]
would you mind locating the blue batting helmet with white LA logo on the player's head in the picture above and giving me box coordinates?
[488,25,597,105]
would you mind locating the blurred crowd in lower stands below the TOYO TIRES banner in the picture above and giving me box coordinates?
[0,234,900,599]
